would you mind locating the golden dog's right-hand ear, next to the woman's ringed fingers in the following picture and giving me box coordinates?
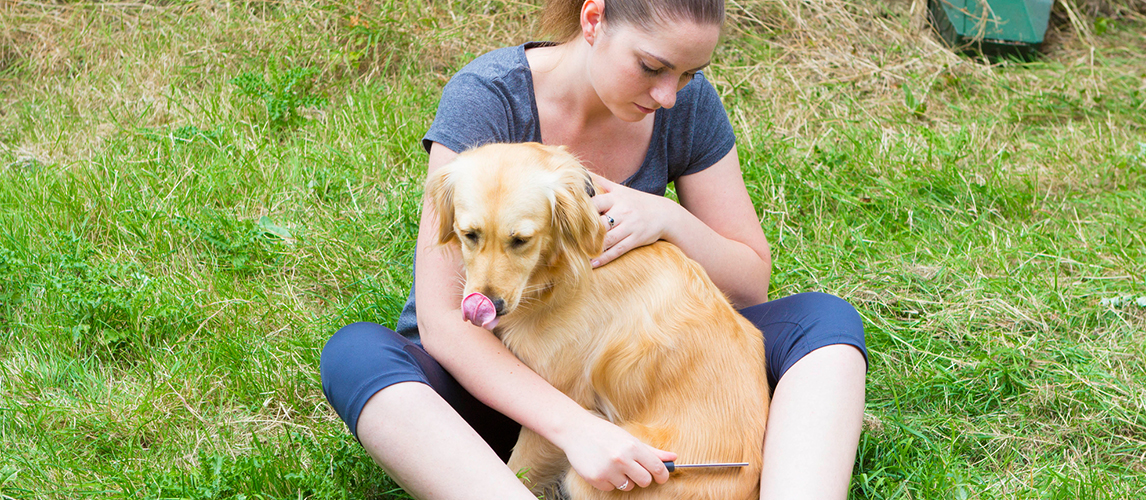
[554,165,605,267]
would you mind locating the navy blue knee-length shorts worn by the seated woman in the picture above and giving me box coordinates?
[319,292,868,460]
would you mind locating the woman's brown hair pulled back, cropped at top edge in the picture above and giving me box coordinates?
[541,0,724,41]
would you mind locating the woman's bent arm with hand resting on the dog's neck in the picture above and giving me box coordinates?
[594,147,772,307]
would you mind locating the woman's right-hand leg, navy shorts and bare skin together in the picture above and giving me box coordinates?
[740,294,868,499]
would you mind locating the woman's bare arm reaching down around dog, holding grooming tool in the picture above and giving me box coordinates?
[415,143,675,491]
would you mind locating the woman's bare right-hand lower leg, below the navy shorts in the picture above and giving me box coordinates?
[760,344,866,500]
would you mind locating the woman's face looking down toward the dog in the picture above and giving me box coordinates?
[588,21,720,122]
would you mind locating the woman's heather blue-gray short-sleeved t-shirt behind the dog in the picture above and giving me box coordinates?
[395,42,736,341]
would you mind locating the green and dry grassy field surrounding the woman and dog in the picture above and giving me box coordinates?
[0,0,1146,499]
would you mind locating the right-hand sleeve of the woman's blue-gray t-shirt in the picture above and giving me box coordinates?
[681,75,736,175]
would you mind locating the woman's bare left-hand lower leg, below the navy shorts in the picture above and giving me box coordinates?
[358,382,536,500]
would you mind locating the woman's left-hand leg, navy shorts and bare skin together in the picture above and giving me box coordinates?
[320,323,534,500]
